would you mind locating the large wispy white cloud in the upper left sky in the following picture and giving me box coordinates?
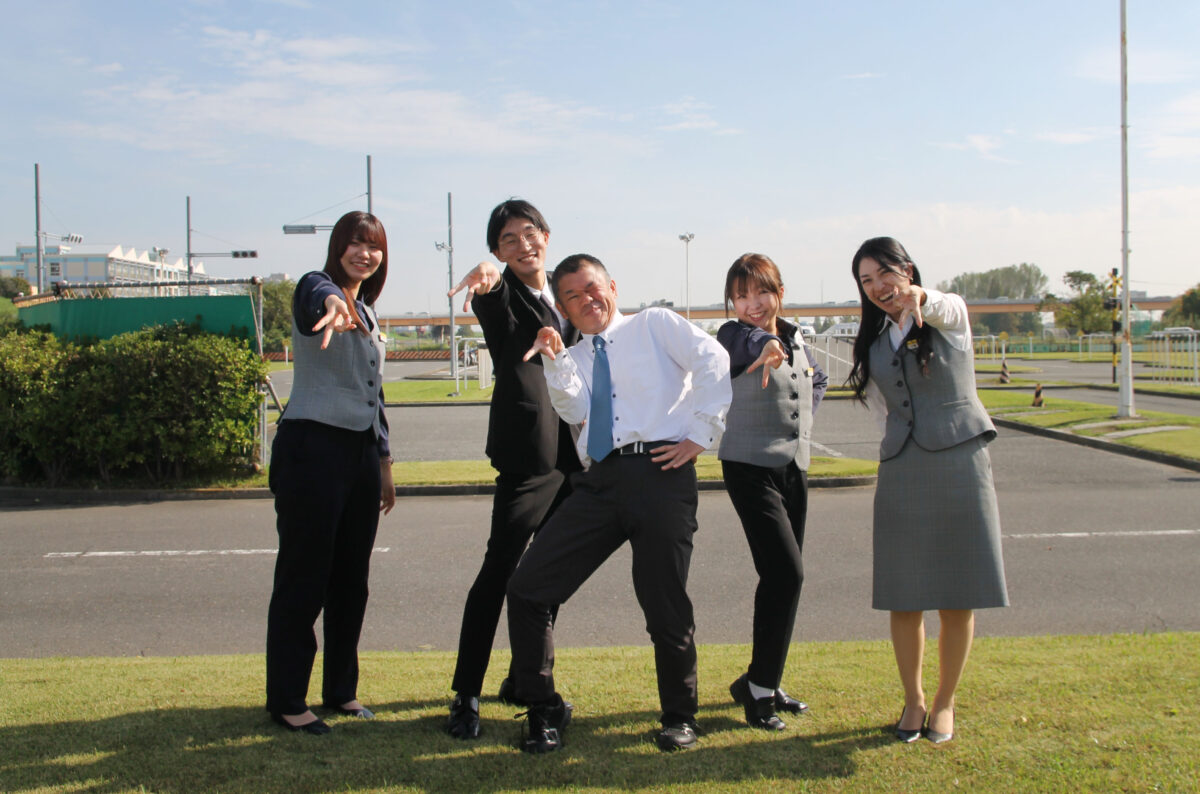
[60,28,646,160]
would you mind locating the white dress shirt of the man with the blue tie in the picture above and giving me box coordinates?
[542,307,733,465]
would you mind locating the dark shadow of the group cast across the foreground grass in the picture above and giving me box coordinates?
[0,699,895,792]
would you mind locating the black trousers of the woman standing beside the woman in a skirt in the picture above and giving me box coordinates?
[721,461,809,688]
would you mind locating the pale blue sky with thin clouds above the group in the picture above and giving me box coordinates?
[0,0,1200,314]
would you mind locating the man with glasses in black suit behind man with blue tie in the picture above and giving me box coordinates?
[446,199,581,739]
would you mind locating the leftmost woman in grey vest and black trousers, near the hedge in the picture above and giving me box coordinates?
[266,212,396,734]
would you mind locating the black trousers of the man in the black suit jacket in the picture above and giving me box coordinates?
[451,470,575,697]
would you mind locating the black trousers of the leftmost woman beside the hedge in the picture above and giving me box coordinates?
[266,420,380,714]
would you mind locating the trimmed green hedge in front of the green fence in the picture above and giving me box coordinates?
[0,325,265,485]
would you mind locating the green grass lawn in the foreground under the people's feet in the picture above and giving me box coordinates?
[0,633,1200,794]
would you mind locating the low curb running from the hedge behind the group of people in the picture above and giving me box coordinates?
[0,475,876,509]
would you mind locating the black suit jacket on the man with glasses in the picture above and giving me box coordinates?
[470,267,582,474]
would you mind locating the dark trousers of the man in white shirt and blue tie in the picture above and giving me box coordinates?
[509,453,697,721]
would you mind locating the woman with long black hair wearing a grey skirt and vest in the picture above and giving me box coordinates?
[850,237,1008,744]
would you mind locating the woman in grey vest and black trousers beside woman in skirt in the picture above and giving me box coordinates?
[716,253,828,730]
